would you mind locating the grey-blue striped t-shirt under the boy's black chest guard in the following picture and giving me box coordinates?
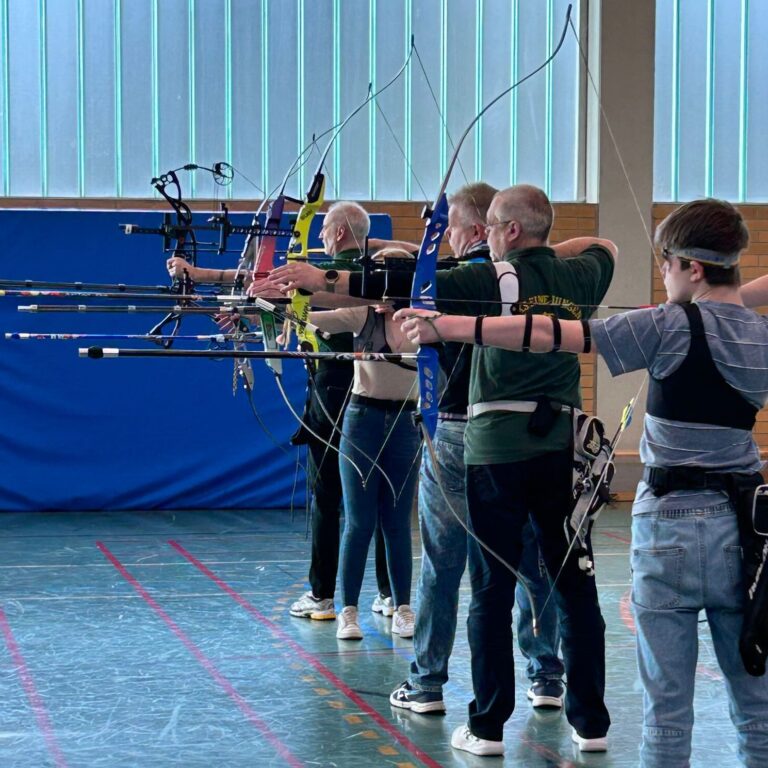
[589,301,768,513]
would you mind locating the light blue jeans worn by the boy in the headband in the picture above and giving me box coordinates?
[632,496,768,768]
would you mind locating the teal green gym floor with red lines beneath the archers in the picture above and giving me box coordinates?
[0,508,738,768]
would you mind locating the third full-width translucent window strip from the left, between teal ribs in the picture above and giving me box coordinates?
[80,0,117,197]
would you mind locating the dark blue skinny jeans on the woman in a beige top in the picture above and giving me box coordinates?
[339,402,419,606]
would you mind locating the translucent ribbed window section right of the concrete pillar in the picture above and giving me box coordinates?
[654,0,768,202]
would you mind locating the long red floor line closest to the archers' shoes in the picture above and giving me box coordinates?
[168,541,442,768]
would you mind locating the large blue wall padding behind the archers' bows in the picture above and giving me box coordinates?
[0,210,392,511]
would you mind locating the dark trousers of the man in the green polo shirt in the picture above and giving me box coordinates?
[467,450,610,741]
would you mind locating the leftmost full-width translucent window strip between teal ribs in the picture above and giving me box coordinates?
[5,0,45,196]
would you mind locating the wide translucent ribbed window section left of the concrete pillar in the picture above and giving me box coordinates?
[0,0,581,200]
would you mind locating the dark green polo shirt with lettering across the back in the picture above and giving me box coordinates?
[437,245,613,465]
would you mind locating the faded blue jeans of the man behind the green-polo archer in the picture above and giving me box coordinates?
[409,420,563,692]
